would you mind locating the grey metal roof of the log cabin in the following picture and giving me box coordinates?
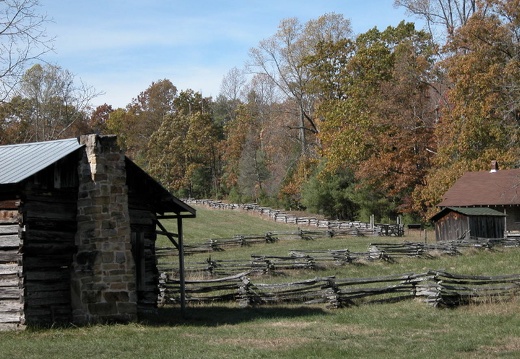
[0,138,83,184]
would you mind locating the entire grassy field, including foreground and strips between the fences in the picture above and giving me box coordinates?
[0,208,520,359]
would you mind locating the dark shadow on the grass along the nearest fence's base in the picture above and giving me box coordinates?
[142,306,327,327]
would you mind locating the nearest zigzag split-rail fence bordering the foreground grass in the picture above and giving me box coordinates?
[159,271,520,308]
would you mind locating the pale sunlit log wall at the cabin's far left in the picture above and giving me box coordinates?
[0,200,24,331]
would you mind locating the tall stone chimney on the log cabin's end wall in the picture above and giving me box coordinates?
[71,135,137,324]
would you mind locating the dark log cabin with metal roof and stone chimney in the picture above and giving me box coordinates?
[0,135,195,329]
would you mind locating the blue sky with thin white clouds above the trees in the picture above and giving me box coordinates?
[41,0,416,108]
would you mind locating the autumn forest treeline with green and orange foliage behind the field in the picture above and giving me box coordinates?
[0,0,520,221]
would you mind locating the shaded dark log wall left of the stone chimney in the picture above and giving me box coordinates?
[20,190,77,325]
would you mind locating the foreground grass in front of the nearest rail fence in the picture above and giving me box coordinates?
[4,301,520,359]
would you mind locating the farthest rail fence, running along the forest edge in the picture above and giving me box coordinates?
[184,199,404,237]
